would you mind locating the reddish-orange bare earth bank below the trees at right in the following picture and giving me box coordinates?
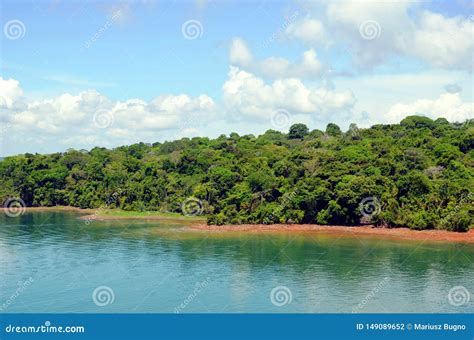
[190,224,474,244]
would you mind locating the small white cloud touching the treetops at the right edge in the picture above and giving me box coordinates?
[386,93,474,123]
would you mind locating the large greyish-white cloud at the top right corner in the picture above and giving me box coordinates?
[286,0,474,71]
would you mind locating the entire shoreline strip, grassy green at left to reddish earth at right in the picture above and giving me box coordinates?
[3,206,474,244]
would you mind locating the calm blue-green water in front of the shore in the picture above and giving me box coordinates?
[0,212,474,313]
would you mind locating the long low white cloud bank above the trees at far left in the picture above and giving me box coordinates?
[0,77,217,151]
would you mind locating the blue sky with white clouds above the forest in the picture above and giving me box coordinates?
[0,0,474,157]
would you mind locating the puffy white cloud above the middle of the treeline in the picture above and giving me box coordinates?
[223,66,355,120]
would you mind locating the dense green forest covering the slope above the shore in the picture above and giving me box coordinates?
[0,116,474,231]
